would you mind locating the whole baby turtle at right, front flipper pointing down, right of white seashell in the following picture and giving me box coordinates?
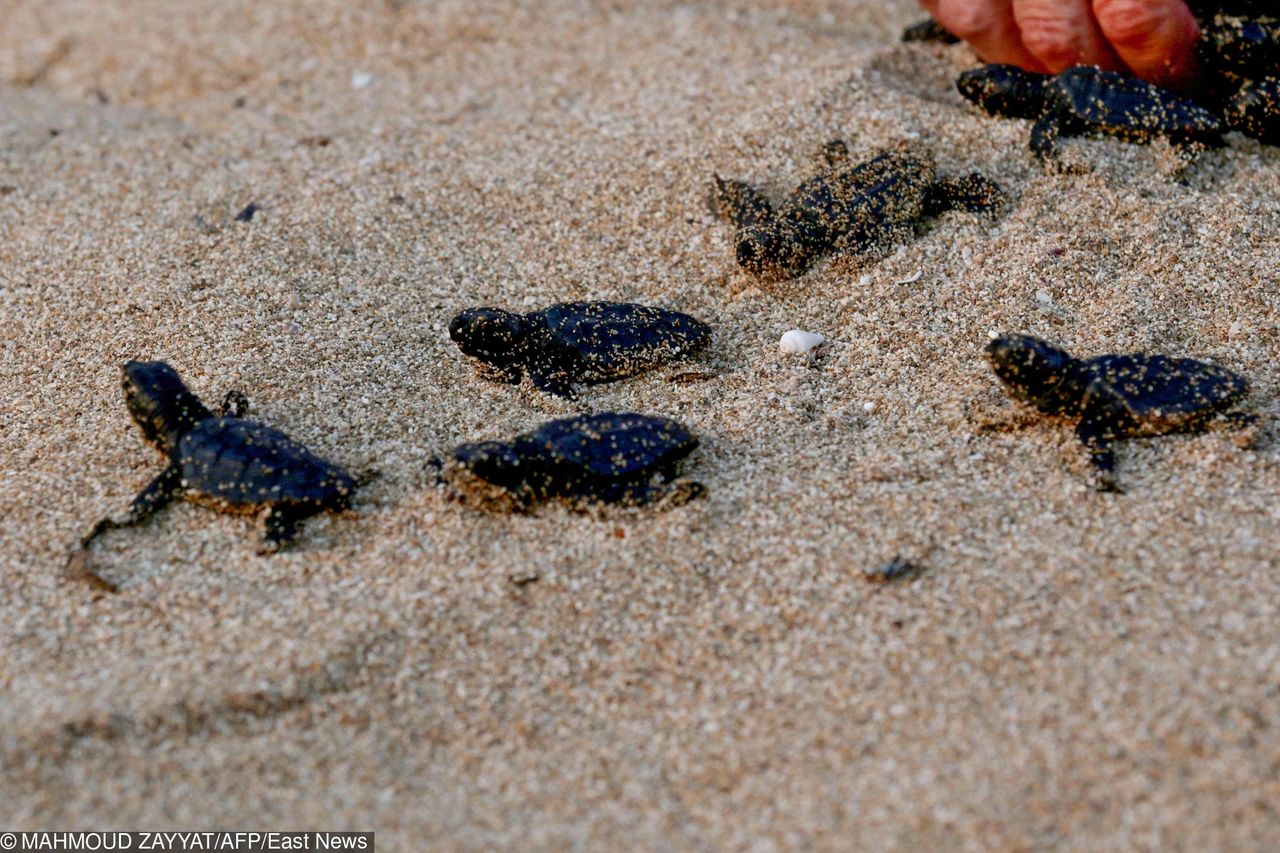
[987,334,1252,492]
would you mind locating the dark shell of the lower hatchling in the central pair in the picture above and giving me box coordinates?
[515,412,698,480]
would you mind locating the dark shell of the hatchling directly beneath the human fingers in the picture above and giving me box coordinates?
[1046,65,1222,138]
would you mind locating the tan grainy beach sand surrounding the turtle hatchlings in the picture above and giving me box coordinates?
[0,0,1280,850]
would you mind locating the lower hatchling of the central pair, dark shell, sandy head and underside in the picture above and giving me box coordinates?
[435,412,705,512]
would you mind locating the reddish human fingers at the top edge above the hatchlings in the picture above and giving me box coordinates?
[920,0,1199,88]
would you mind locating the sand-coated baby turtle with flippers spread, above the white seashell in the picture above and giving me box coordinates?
[712,140,1002,280]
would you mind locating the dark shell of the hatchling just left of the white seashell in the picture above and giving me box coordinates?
[536,302,712,382]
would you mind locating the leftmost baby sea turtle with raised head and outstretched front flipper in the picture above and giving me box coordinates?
[73,361,356,584]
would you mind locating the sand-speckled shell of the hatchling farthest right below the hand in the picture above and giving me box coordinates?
[1084,353,1249,433]
